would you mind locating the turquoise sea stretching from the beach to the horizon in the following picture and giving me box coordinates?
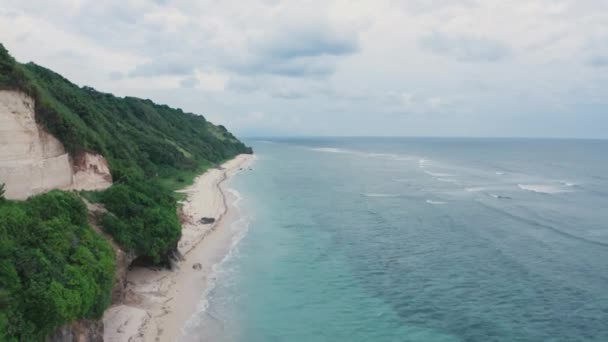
[180,138,608,342]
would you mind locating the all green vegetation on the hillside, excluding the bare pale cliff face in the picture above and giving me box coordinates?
[0,44,252,341]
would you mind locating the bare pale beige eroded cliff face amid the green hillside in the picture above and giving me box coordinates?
[0,90,112,199]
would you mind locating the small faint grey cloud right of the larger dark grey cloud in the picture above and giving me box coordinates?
[419,32,511,62]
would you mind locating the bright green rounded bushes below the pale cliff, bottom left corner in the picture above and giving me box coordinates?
[0,191,114,341]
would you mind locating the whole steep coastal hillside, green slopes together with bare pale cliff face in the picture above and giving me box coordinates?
[0,45,252,341]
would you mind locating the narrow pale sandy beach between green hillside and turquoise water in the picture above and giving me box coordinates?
[103,155,254,342]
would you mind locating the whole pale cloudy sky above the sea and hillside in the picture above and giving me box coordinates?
[0,0,608,138]
